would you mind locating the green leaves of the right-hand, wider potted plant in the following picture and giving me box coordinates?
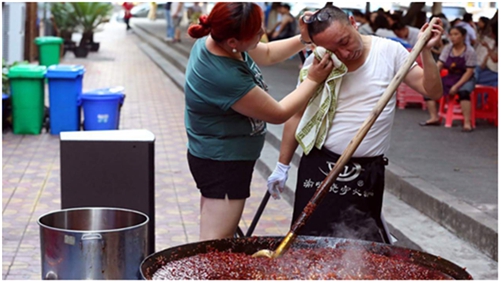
[69,2,113,33]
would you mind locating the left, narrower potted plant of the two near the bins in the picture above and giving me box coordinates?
[50,3,78,55]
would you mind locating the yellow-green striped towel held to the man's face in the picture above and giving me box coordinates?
[296,47,348,155]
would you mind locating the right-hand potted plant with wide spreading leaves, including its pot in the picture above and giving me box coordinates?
[70,2,113,57]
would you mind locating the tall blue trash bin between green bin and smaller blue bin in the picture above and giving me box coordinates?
[45,65,85,135]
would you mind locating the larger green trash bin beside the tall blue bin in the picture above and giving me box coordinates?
[7,64,46,135]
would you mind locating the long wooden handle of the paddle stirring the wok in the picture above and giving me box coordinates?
[274,18,438,257]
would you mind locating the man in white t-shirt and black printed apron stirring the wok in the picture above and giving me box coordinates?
[268,6,442,243]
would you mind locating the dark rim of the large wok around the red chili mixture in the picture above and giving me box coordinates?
[141,236,472,280]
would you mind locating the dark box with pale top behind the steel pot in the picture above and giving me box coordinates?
[60,130,155,254]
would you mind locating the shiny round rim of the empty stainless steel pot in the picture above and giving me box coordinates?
[37,207,150,233]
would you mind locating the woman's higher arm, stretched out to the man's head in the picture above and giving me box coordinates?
[249,35,304,66]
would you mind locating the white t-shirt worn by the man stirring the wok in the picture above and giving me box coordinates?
[304,36,416,157]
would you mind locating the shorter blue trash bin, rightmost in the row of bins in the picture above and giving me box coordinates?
[81,86,125,131]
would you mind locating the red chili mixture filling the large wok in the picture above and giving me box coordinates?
[152,247,452,280]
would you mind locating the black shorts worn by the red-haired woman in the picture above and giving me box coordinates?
[188,150,256,199]
